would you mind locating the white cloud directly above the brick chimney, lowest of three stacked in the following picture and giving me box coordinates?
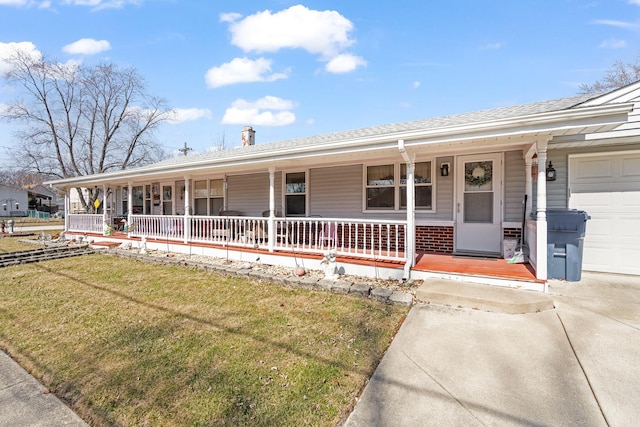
[222,96,296,126]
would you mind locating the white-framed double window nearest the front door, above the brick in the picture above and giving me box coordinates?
[365,161,433,210]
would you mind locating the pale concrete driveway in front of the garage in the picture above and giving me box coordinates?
[345,273,640,427]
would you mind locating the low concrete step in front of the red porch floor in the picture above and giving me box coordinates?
[416,279,554,314]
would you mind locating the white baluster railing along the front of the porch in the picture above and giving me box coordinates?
[69,214,407,260]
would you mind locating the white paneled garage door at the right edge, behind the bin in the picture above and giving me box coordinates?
[569,152,640,275]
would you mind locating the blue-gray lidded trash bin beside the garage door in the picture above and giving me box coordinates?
[547,209,591,282]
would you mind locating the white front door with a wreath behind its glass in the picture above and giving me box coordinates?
[455,153,502,254]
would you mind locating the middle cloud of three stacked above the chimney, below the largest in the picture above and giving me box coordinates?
[205,58,287,88]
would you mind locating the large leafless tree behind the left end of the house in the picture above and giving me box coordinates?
[4,51,170,212]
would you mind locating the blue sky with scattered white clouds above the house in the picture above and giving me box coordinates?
[0,0,640,161]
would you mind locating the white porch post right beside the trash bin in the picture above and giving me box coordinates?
[536,140,547,280]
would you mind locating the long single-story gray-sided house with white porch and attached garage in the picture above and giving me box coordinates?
[51,83,640,281]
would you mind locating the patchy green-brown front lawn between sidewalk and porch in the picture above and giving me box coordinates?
[0,252,407,426]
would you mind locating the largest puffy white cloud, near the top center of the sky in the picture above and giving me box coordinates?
[227,5,354,59]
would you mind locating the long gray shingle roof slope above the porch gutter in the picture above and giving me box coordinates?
[139,94,597,170]
